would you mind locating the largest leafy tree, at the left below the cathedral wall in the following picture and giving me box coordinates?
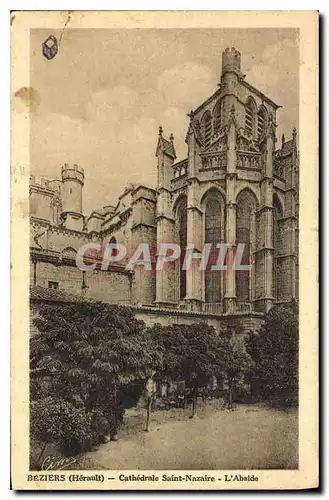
[30,301,160,456]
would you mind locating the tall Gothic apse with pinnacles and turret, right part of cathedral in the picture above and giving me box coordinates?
[156,48,298,314]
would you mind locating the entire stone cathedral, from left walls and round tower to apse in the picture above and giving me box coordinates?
[30,48,299,334]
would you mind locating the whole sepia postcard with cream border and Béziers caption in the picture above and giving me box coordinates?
[11,11,319,490]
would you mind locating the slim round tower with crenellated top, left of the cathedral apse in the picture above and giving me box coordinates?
[62,163,85,230]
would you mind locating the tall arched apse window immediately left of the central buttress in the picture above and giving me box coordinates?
[205,190,223,302]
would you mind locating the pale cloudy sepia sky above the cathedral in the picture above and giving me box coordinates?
[30,28,299,214]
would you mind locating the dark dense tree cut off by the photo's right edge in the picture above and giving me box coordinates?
[246,301,299,406]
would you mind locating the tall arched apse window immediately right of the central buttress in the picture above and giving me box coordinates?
[235,189,256,302]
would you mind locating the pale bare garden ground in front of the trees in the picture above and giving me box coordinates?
[80,405,298,470]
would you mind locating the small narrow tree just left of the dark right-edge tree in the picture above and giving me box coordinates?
[217,327,252,409]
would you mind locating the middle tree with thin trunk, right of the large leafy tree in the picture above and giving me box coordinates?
[151,323,219,417]
